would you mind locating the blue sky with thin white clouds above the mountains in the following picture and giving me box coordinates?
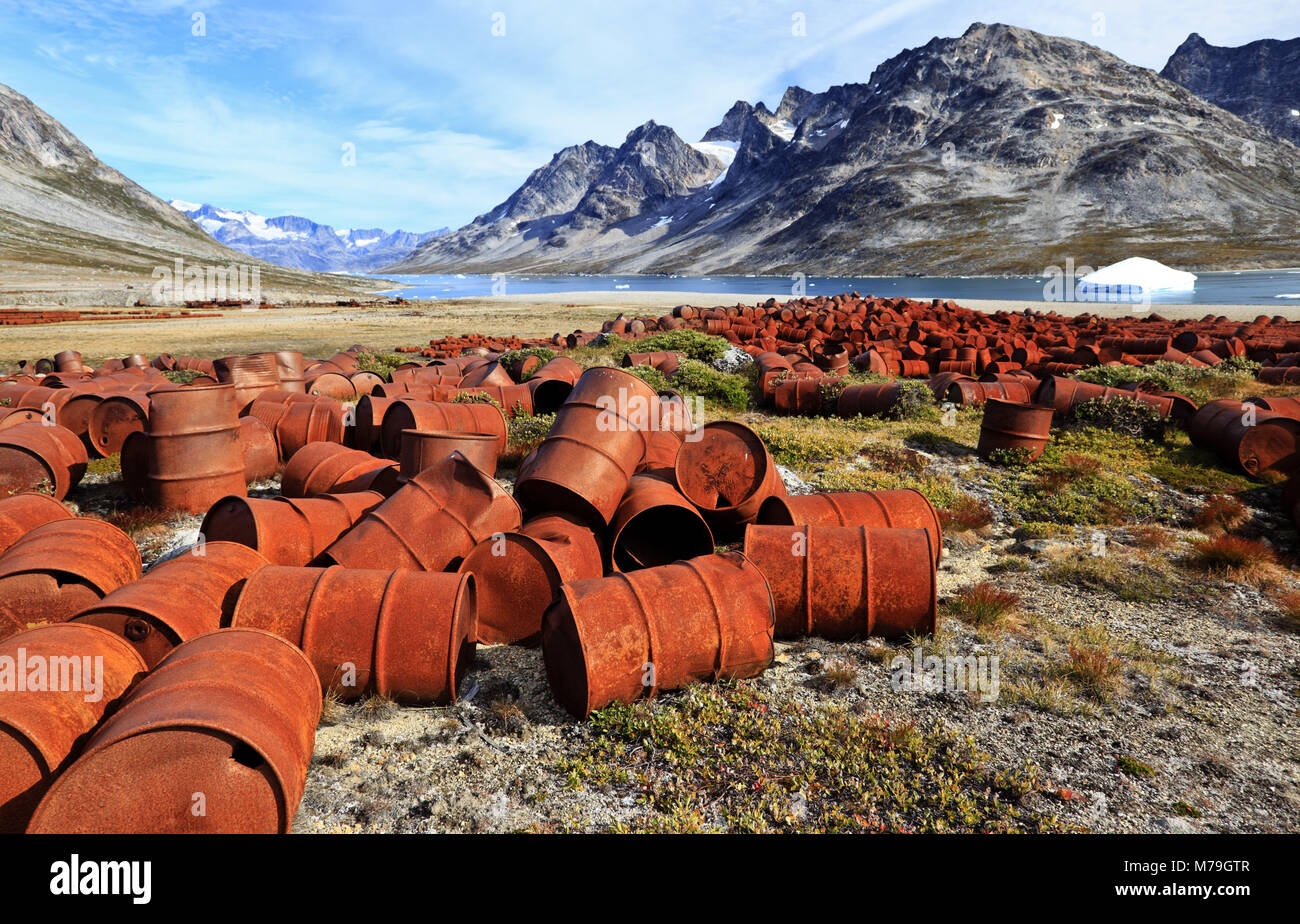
[0,0,1300,231]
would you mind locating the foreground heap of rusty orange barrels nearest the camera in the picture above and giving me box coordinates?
[0,360,943,833]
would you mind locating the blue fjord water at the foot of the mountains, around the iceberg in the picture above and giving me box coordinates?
[377,269,1300,306]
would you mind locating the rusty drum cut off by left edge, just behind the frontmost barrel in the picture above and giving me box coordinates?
[0,624,147,834]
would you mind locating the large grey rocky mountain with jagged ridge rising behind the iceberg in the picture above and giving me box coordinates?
[393,23,1300,274]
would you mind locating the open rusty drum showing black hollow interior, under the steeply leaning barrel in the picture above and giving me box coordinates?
[610,474,714,572]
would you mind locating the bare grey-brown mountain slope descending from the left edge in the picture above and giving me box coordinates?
[0,84,379,304]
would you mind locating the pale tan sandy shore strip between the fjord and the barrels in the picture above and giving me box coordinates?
[0,291,1296,366]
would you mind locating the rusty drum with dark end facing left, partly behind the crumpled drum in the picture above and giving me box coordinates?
[197,491,384,565]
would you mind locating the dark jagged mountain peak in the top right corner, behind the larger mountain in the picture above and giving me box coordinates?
[1160,32,1300,146]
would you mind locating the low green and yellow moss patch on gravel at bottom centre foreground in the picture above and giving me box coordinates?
[562,684,1063,833]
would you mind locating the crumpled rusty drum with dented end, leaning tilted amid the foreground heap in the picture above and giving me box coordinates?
[320,452,523,571]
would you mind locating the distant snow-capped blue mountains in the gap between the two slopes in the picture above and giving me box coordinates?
[170,199,447,273]
